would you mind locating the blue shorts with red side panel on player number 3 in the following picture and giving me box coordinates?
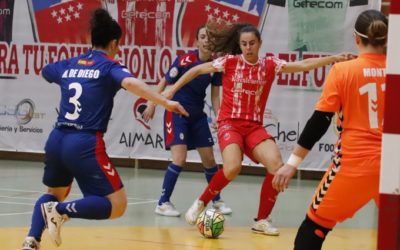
[43,128,123,196]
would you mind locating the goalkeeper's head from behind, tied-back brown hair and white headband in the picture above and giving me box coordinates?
[354,10,388,47]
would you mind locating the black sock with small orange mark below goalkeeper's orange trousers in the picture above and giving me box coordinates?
[294,216,332,250]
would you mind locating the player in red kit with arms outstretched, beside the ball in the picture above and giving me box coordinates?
[165,24,346,235]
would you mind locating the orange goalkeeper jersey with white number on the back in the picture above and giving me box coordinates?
[316,53,386,174]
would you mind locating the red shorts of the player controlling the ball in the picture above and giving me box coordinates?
[218,120,273,163]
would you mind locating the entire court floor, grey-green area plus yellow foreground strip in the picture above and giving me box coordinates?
[0,160,377,250]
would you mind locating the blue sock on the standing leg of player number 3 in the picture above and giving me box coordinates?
[28,194,58,241]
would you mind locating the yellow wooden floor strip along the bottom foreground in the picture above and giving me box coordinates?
[0,226,376,250]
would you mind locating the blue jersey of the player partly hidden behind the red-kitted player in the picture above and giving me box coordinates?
[165,50,222,114]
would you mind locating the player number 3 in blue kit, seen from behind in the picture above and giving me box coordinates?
[22,9,188,250]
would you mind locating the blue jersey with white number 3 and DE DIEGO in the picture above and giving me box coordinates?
[42,50,132,132]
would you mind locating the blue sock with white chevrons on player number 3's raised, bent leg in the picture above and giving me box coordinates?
[56,196,112,220]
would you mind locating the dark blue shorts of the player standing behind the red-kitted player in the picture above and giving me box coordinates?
[164,111,214,150]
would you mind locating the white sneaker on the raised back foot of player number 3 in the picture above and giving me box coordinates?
[41,201,68,246]
